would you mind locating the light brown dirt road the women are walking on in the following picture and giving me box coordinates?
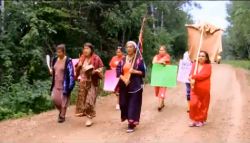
[0,65,250,143]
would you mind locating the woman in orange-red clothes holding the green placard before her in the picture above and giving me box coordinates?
[152,45,171,111]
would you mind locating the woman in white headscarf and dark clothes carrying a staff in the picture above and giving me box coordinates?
[116,41,146,133]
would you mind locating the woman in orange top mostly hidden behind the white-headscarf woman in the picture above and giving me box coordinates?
[109,46,125,110]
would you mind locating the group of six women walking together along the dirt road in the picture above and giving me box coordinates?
[50,41,211,132]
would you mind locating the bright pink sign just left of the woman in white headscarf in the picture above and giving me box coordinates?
[103,70,119,92]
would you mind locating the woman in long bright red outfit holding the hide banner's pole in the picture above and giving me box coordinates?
[189,51,212,127]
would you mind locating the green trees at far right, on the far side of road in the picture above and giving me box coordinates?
[223,1,250,60]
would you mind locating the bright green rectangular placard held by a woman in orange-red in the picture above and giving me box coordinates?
[151,64,178,87]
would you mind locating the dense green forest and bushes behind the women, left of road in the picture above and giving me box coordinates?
[0,0,199,120]
